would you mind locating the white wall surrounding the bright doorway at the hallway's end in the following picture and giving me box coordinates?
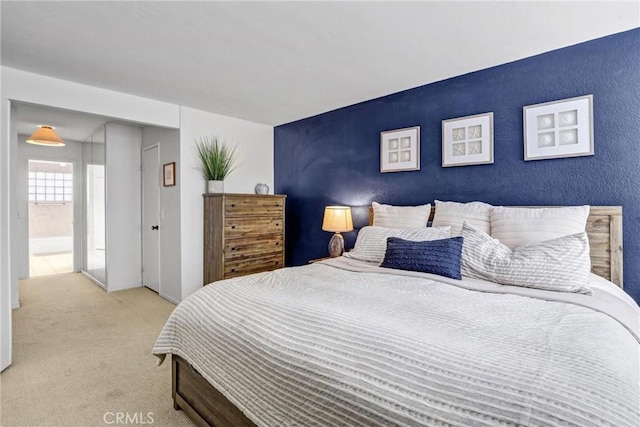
[12,135,83,284]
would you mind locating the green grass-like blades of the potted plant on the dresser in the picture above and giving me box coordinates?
[196,136,238,181]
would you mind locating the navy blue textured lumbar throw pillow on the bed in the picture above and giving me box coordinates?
[380,236,463,280]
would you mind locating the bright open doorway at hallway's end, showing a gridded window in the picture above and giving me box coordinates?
[28,160,74,277]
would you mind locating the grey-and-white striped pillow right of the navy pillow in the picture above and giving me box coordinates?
[460,222,592,294]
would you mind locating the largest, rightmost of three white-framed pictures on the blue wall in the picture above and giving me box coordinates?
[523,95,593,161]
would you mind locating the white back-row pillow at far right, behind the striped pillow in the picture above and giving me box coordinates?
[491,206,589,249]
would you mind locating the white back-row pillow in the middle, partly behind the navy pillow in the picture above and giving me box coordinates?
[433,200,493,236]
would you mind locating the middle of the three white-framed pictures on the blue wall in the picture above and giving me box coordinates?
[442,113,493,168]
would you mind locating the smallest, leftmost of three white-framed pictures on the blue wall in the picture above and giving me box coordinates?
[380,126,420,172]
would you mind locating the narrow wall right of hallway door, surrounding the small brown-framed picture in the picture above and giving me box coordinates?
[142,127,182,303]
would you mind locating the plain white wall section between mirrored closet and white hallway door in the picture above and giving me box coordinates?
[105,123,142,292]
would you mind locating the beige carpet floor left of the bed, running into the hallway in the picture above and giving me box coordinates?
[0,273,194,427]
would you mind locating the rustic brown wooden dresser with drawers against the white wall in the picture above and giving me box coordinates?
[204,194,286,285]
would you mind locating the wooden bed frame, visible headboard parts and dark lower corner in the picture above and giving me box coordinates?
[171,206,623,427]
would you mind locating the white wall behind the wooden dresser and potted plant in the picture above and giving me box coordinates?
[178,107,273,299]
